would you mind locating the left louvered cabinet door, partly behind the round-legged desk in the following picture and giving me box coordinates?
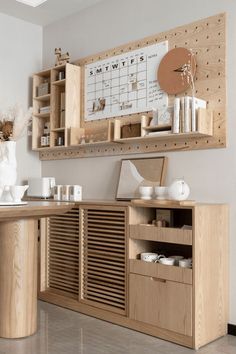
[47,208,79,298]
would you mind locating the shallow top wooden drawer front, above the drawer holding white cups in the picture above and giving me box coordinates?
[129,224,192,245]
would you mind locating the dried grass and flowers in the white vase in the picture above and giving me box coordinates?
[0,105,32,142]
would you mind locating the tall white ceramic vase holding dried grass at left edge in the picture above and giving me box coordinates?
[0,141,17,200]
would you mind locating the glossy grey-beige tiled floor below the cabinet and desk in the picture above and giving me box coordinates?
[0,302,236,354]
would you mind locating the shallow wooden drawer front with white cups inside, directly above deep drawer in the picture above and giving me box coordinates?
[129,259,193,284]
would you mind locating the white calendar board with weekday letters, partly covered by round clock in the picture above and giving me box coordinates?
[84,41,168,121]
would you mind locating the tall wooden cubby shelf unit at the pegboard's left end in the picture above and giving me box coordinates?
[32,64,80,151]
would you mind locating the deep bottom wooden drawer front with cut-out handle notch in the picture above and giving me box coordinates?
[129,274,192,336]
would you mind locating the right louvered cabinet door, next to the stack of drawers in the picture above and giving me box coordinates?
[81,207,126,315]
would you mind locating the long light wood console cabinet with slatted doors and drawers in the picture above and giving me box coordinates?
[39,201,228,348]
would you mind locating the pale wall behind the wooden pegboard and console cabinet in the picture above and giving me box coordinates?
[42,0,236,324]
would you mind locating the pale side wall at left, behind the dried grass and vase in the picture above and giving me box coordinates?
[0,13,42,183]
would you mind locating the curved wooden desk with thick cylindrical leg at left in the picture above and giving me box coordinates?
[0,202,74,338]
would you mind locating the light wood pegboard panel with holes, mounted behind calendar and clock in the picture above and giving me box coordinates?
[40,13,227,160]
